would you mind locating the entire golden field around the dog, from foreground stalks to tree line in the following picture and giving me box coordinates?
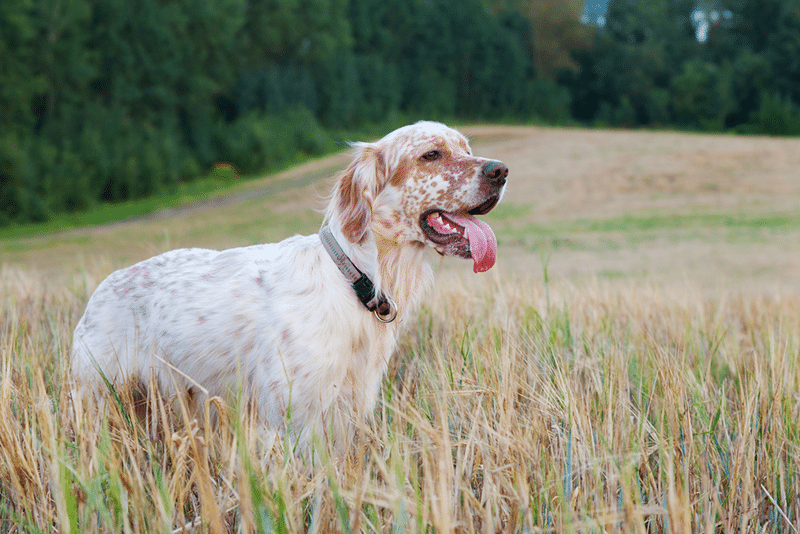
[0,126,800,532]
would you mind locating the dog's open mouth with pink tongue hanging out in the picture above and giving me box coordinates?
[420,196,500,273]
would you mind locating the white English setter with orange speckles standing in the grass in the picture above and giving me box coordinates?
[73,122,508,445]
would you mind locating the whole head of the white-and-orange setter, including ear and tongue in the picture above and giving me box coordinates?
[327,122,508,272]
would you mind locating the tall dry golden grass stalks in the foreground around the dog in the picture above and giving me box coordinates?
[0,268,800,533]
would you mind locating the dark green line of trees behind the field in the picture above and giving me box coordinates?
[0,0,800,226]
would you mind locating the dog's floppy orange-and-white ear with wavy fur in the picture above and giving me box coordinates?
[327,143,386,244]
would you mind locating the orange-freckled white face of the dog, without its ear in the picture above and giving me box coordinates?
[374,125,505,268]
